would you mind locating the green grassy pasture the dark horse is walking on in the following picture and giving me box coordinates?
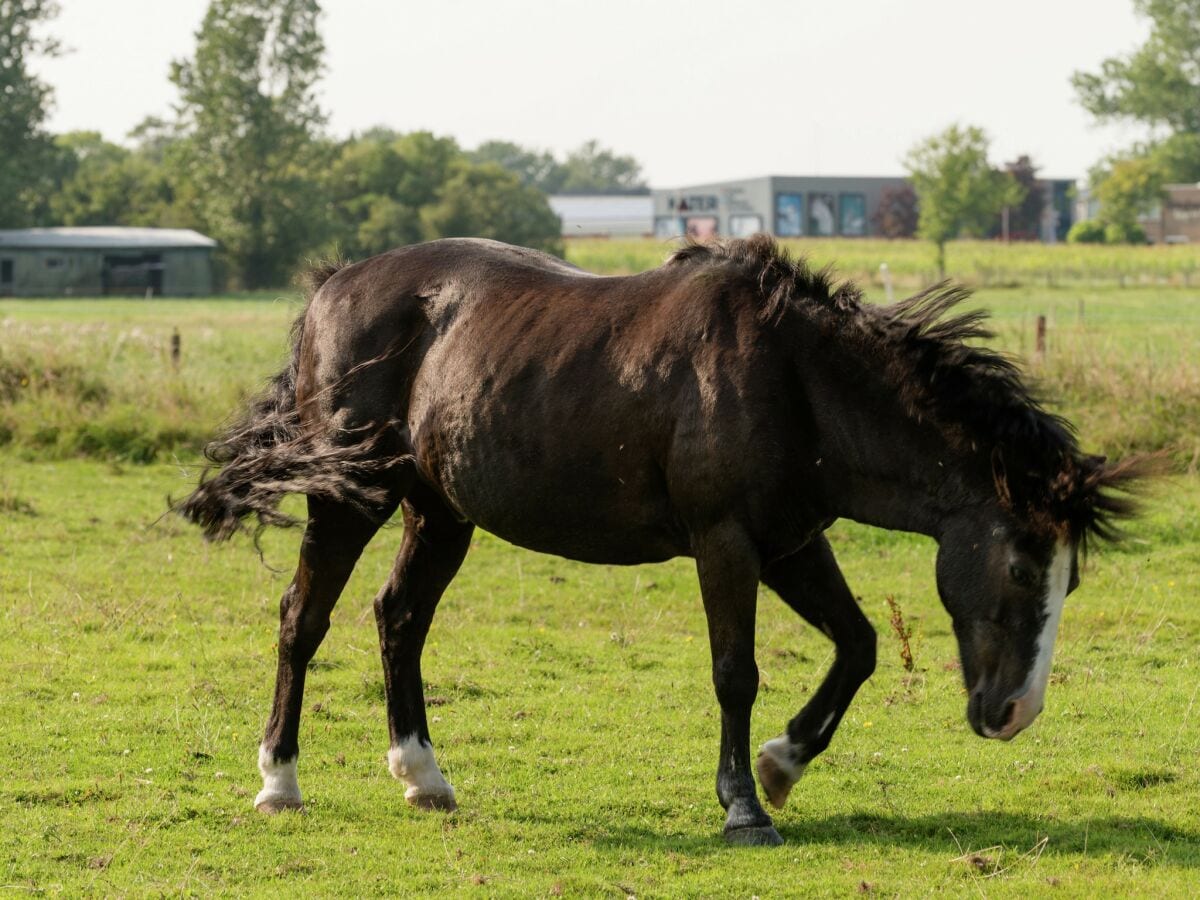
[0,245,1200,896]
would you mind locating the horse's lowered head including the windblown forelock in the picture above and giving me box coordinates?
[937,441,1147,740]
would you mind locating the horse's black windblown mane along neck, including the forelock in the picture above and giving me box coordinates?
[667,234,1146,540]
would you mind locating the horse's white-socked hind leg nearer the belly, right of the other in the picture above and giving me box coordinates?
[374,491,474,810]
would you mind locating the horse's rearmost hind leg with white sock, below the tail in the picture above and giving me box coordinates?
[254,493,398,812]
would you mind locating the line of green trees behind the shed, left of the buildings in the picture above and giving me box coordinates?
[0,0,644,288]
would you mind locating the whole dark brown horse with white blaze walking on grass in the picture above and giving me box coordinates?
[178,235,1142,845]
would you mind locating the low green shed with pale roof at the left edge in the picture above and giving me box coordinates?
[0,228,217,296]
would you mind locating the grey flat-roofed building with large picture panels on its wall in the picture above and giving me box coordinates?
[653,175,1074,244]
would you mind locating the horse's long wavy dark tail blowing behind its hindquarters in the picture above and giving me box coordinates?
[175,263,393,540]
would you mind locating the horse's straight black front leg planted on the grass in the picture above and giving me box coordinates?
[695,524,784,845]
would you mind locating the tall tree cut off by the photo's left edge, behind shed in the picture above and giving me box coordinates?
[0,0,59,228]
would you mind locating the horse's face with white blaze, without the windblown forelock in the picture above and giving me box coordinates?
[937,515,1079,740]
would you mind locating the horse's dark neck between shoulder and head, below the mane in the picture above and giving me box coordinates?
[817,355,986,538]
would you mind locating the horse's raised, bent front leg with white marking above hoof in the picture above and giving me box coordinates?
[758,535,875,809]
